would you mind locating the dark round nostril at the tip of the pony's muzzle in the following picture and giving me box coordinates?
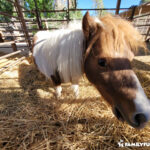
[134,113,147,126]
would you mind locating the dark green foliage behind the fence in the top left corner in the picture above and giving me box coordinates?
[0,0,13,22]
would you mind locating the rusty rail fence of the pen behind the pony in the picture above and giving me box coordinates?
[0,0,150,72]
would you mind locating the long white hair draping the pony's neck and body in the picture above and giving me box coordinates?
[33,22,84,83]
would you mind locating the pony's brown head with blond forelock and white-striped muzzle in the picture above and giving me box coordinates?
[83,13,150,128]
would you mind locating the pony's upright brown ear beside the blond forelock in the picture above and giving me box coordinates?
[82,12,103,40]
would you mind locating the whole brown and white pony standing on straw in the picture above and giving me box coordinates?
[33,12,150,128]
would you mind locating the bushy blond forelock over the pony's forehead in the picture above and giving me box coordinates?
[101,15,145,56]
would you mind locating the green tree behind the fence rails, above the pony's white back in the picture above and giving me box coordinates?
[24,0,82,19]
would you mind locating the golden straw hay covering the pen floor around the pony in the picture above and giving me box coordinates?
[0,57,150,150]
